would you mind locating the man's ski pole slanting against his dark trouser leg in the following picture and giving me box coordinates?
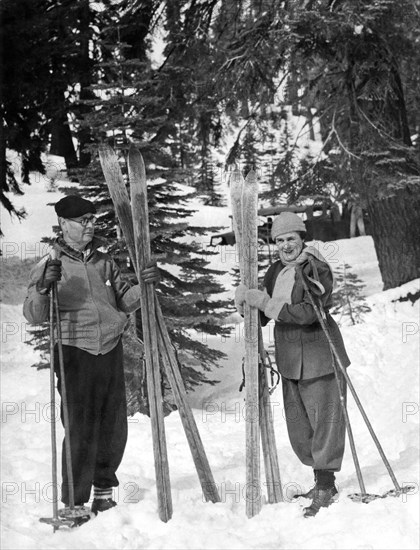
[51,251,74,510]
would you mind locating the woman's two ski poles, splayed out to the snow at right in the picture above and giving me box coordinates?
[301,266,401,494]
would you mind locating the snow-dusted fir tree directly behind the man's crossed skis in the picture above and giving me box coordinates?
[65,5,229,410]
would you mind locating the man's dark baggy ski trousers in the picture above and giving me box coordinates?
[55,341,127,505]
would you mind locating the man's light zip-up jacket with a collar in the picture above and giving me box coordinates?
[23,238,140,355]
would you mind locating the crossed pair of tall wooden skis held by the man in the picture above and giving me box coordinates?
[99,145,220,522]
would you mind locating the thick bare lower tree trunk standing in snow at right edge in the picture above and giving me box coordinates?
[368,188,420,290]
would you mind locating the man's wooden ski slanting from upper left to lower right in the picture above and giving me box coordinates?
[99,145,220,512]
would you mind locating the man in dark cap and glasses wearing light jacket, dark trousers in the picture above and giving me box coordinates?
[23,195,159,514]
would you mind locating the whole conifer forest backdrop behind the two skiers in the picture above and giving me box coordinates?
[0,0,420,411]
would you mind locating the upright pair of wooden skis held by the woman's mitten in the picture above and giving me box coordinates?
[230,169,283,518]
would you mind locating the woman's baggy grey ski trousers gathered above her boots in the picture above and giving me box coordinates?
[282,373,347,472]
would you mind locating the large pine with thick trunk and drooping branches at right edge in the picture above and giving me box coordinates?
[278,0,420,289]
